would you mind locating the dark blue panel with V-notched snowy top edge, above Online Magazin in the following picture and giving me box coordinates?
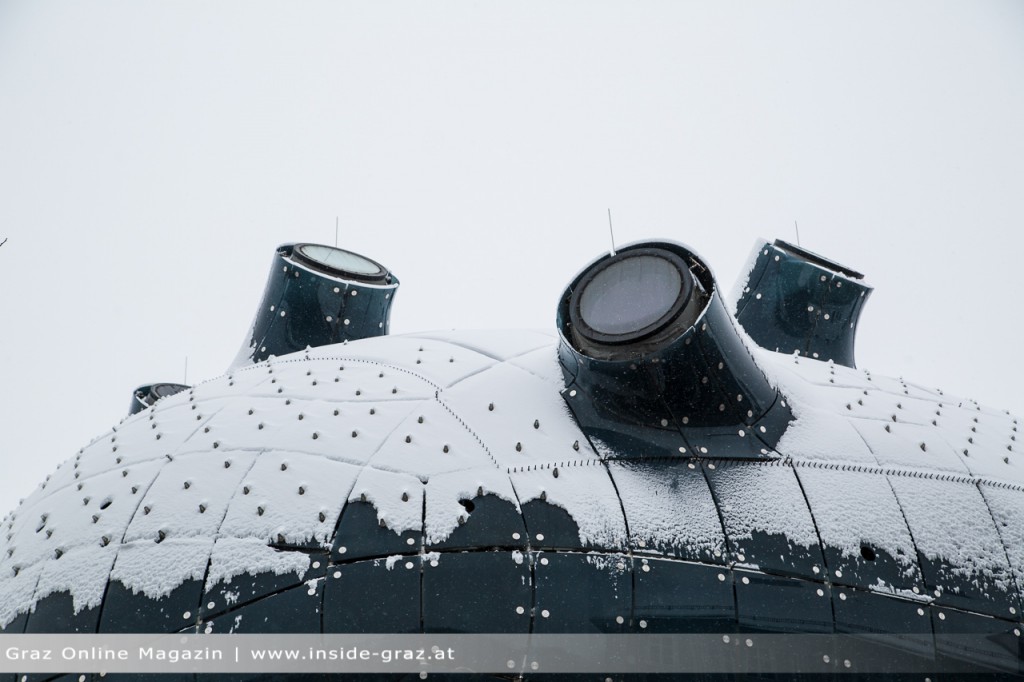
[99,580,203,634]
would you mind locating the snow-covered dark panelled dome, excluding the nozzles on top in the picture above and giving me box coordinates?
[0,238,1024,675]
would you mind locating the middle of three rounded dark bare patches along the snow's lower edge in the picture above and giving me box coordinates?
[426,495,526,552]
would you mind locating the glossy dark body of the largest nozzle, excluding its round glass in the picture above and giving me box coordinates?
[557,242,793,459]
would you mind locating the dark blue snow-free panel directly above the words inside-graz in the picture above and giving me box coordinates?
[324,555,421,634]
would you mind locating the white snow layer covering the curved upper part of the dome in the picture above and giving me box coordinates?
[0,332,1024,624]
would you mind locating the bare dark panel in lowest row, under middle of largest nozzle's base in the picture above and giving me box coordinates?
[633,558,736,633]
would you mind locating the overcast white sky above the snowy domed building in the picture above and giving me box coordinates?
[0,0,1024,514]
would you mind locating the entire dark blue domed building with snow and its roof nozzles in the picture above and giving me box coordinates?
[0,237,1024,680]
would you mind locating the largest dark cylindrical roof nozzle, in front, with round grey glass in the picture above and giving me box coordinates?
[557,242,792,458]
